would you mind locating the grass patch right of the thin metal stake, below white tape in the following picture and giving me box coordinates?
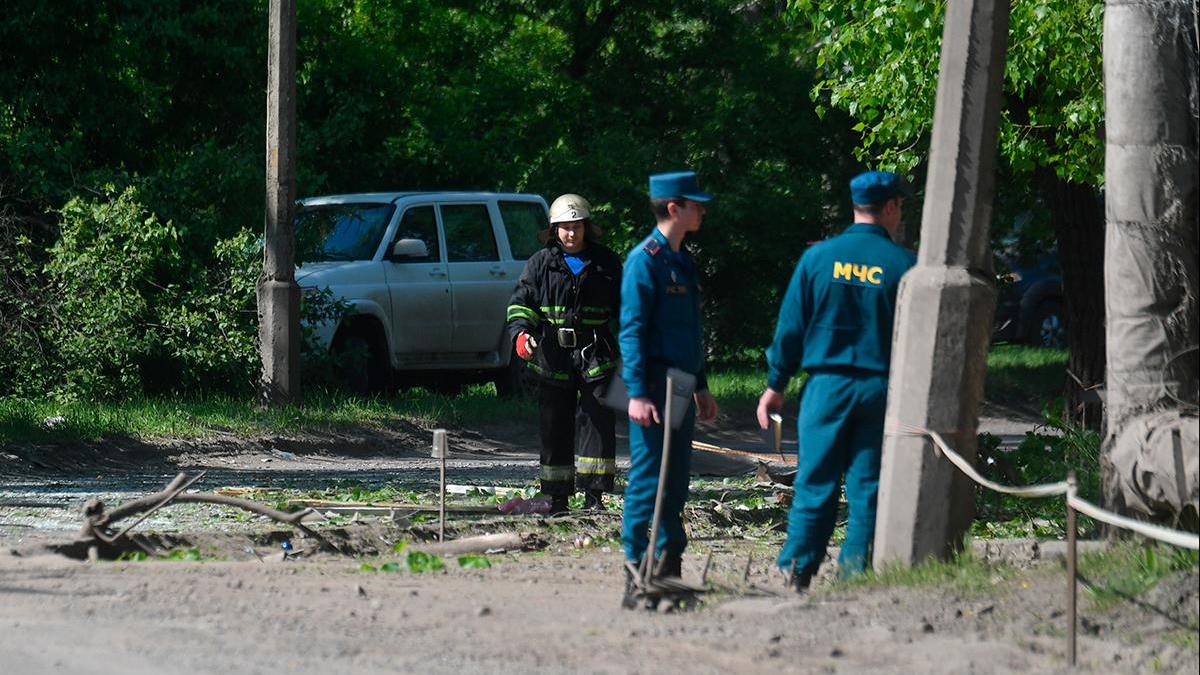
[1079,542,1200,609]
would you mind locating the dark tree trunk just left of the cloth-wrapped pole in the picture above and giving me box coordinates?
[1037,169,1104,431]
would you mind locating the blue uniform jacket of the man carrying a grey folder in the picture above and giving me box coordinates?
[618,228,708,399]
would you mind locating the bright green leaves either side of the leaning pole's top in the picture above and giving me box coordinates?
[790,0,1104,186]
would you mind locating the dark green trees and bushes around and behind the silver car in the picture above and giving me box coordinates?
[0,0,853,396]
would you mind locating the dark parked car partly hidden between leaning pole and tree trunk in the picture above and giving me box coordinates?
[992,252,1067,348]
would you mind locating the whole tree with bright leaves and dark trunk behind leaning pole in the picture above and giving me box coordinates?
[788,0,1105,424]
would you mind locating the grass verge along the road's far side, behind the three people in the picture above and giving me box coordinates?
[0,345,1067,444]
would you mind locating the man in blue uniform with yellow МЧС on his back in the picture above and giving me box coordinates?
[757,171,916,592]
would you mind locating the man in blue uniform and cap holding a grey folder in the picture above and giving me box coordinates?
[619,172,716,608]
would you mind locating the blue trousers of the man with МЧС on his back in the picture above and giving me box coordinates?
[778,371,888,575]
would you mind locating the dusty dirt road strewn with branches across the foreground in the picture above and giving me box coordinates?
[0,403,1200,675]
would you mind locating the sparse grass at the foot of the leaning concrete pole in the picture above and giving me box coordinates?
[834,550,1016,596]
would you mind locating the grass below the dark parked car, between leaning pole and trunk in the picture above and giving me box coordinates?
[984,345,1067,407]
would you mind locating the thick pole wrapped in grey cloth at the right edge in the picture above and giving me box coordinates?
[1100,0,1200,528]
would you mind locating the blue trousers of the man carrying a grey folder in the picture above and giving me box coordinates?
[620,396,696,562]
